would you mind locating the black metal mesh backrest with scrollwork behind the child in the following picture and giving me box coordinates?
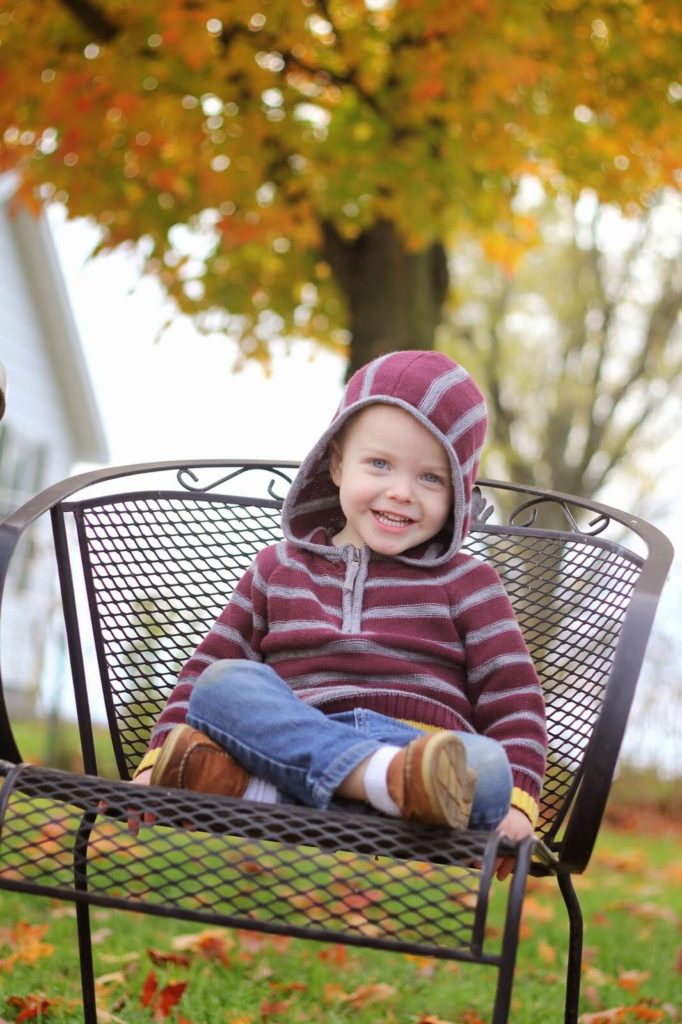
[0,464,671,872]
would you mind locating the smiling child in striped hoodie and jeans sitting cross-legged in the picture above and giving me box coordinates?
[135,351,547,864]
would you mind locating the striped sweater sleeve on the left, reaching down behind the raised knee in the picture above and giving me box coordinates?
[135,556,266,775]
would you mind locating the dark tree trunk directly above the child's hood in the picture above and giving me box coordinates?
[324,220,449,376]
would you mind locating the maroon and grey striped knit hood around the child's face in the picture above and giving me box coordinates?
[282,351,487,566]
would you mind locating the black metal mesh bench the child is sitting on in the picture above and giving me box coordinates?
[0,460,672,1024]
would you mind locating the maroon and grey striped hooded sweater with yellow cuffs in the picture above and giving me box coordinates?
[143,351,547,823]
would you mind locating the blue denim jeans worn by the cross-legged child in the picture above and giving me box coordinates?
[187,660,512,829]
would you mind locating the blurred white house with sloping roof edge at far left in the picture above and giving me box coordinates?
[0,175,108,715]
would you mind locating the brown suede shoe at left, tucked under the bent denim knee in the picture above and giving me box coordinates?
[150,725,250,797]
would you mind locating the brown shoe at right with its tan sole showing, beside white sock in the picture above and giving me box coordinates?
[387,731,476,828]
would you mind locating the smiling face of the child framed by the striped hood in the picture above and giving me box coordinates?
[330,403,453,557]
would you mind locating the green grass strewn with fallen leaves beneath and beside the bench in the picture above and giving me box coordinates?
[0,825,682,1024]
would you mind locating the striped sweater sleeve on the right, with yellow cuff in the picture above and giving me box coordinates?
[456,562,547,825]
